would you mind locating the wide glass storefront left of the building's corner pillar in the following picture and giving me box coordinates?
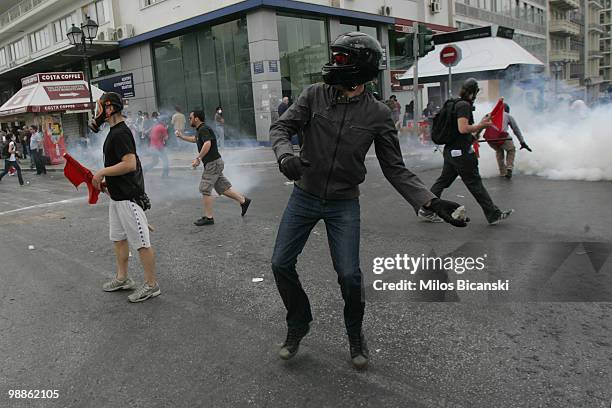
[153,18,256,140]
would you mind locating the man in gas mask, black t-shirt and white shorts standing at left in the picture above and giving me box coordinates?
[90,92,161,302]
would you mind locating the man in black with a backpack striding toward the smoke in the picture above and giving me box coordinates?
[419,78,514,225]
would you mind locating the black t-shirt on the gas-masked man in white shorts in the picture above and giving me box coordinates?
[103,122,144,201]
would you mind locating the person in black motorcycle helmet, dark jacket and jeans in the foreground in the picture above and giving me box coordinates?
[270,32,466,369]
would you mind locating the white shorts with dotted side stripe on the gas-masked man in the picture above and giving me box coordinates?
[108,200,151,250]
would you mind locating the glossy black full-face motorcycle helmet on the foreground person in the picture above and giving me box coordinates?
[322,32,382,89]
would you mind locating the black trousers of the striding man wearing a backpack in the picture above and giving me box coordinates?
[431,149,500,222]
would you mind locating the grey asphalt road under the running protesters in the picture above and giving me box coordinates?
[0,151,612,407]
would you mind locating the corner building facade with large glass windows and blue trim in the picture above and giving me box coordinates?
[0,0,460,142]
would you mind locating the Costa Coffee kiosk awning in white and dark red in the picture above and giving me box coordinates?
[0,72,104,117]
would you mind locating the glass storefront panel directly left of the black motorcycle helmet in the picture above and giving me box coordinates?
[277,14,329,100]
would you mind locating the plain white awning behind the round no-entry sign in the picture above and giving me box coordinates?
[399,37,544,85]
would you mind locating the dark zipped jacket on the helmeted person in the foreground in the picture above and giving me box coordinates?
[270,83,435,210]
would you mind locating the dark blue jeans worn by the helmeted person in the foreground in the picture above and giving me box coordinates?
[272,187,365,334]
